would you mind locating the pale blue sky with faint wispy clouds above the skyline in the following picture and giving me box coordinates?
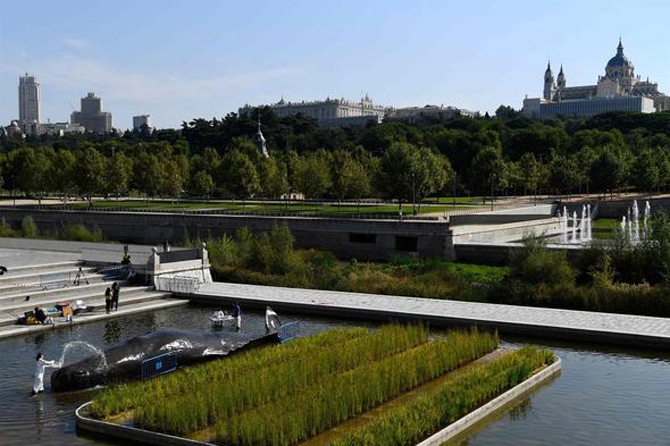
[0,0,670,129]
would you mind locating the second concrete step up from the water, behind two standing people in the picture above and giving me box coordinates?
[0,286,154,325]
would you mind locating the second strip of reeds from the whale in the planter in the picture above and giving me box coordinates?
[133,325,428,435]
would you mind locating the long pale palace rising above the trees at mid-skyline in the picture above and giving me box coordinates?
[238,95,387,127]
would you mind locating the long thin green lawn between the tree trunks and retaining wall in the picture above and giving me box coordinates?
[60,200,468,216]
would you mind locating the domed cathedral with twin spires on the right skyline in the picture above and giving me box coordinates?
[522,39,670,118]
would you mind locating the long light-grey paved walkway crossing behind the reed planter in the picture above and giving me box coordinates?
[187,282,670,349]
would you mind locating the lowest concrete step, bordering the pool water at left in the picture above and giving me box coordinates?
[0,297,188,339]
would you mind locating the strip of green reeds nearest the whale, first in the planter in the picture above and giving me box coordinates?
[90,328,370,419]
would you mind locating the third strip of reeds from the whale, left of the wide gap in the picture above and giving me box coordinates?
[216,332,497,446]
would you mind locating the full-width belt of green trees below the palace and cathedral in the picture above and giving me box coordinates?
[5,106,670,201]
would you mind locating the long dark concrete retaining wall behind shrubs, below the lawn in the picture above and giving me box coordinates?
[0,208,454,260]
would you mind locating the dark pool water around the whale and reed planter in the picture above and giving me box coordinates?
[0,306,670,446]
